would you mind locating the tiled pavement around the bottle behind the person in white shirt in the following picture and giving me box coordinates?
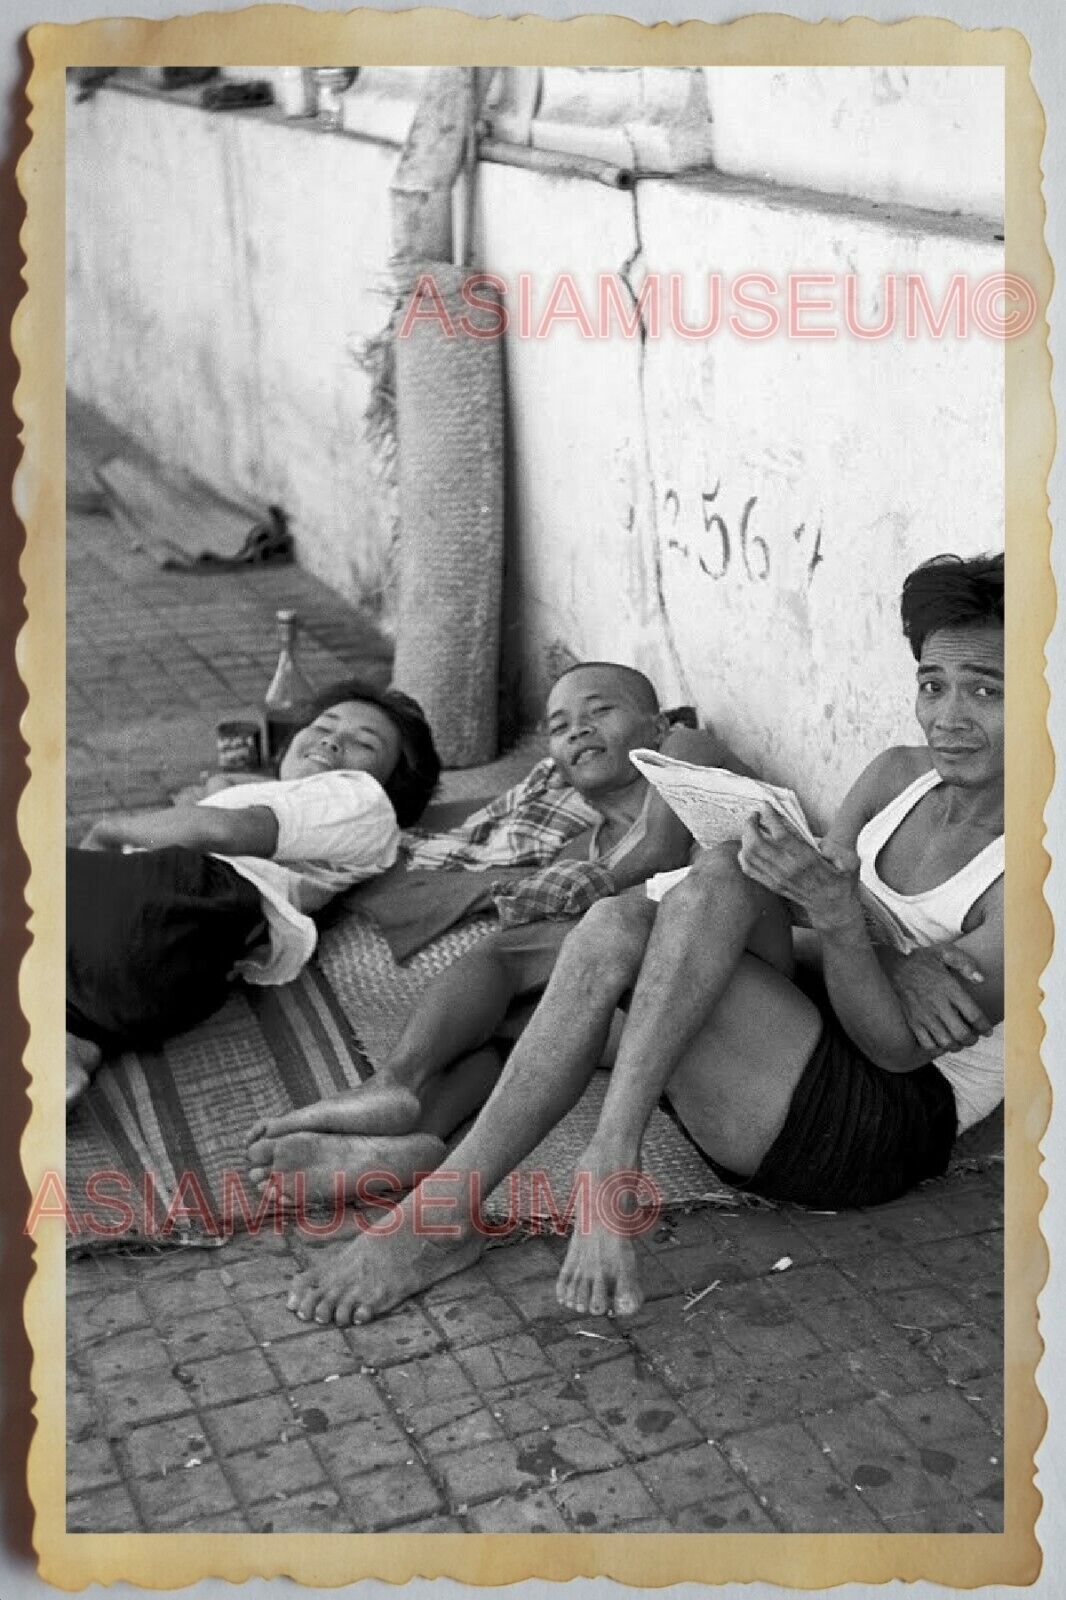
[67,515,391,835]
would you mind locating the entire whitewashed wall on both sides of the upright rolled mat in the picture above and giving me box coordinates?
[69,72,1004,819]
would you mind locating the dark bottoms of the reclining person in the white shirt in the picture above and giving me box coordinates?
[67,846,262,1053]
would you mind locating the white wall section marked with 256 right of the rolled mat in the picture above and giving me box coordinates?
[470,168,1004,819]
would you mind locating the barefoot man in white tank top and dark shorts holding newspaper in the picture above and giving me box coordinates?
[278,555,1004,1323]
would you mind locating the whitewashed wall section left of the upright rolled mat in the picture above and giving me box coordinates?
[67,90,395,602]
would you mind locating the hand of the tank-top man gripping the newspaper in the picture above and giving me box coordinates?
[738,805,864,933]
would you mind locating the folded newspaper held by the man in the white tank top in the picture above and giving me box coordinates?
[629,750,917,955]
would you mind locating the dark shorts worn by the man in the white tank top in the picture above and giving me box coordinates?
[711,1018,957,1211]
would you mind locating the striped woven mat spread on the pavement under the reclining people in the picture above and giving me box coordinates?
[67,914,731,1250]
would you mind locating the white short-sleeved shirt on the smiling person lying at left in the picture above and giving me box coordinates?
[198,771,400,984]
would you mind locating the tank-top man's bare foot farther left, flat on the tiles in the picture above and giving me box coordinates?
[288,1200,485,1325]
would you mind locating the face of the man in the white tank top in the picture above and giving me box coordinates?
[916,627,1004,789]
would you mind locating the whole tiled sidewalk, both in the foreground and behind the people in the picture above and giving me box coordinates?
[67,428,1002,1533]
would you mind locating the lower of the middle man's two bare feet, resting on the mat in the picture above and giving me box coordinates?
[248,1133,445,1203]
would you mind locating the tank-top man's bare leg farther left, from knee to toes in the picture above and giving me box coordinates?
[288,893,655,1323]
